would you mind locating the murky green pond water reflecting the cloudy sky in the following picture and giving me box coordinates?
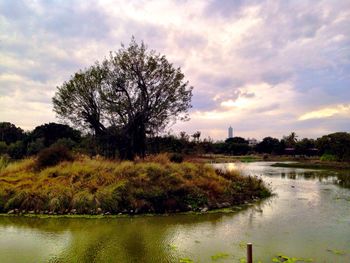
[0,163,350,263]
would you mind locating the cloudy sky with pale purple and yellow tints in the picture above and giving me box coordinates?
[0,0,350,140]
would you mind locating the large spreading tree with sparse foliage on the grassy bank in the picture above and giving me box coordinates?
[53,39,192,159]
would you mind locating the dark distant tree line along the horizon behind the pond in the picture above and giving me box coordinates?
[0,122,350,161]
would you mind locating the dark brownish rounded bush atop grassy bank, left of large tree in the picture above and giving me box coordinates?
[35,145,74,169]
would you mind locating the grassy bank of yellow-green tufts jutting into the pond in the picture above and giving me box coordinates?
[0,156,271,214]
